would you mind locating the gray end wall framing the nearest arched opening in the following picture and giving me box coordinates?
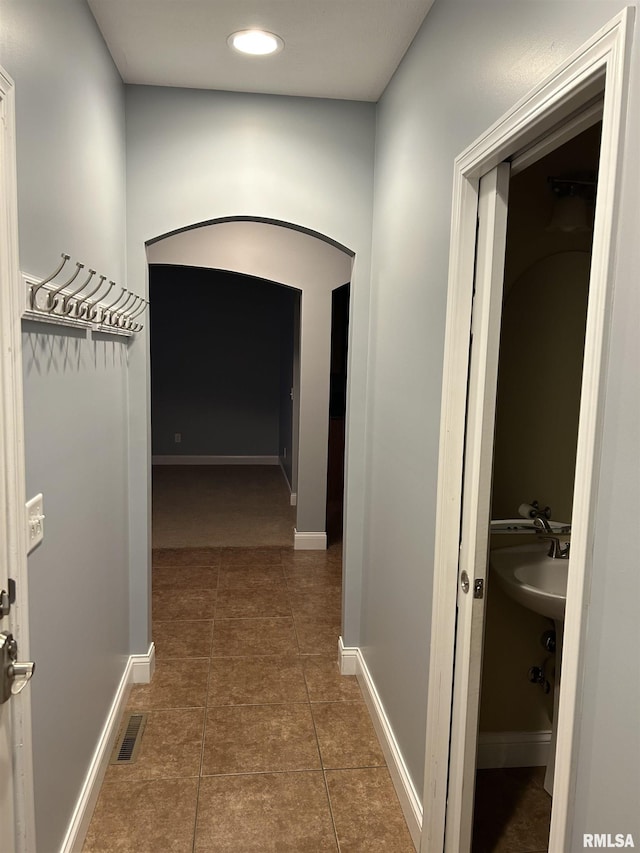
[127,86,375,648]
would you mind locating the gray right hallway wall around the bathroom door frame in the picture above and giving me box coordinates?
[361,0,640,836]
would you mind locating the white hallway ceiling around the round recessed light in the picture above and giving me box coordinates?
[87,0,433,101]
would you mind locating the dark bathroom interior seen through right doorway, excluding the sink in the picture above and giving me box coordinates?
[472,122,602,853]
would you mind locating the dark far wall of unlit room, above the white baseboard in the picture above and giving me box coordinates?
[149,265,294,456]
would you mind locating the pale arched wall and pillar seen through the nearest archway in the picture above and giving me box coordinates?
[147,217,353,549]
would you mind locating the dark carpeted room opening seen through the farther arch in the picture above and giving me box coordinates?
[149,265,300,548]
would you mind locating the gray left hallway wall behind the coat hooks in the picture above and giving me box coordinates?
[0,0,129,851]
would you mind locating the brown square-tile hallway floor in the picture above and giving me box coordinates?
[84,548,414,853]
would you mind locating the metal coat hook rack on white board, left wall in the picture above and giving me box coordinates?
[22,253,149,337]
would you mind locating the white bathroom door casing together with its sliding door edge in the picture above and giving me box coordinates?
[421,12,629,853]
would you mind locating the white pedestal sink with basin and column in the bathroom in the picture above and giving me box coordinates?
[489,541,569,794]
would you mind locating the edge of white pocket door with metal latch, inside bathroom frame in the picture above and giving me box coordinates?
[445,163,510,853]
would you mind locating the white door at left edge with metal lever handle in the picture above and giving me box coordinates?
[0,68,35,851]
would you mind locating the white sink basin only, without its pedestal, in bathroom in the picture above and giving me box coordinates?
[489,542,569,622]
